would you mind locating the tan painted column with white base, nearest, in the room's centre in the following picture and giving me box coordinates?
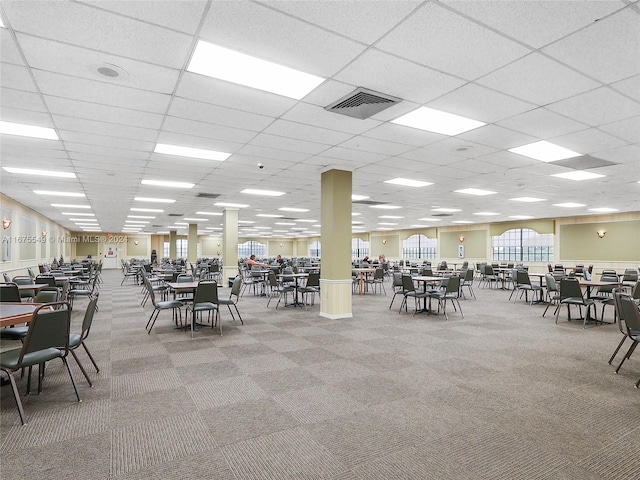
[320,170,353,319]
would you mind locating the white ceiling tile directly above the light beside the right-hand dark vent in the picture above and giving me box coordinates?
[497,108,587,139]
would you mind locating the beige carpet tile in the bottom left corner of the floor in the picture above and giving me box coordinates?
[0,432,111,480]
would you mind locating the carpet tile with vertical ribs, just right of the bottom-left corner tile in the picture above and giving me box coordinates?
[111,413,216,476]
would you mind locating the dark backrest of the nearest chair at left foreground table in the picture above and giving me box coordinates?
[18,302,71,365]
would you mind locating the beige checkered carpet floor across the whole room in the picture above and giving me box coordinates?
[0,271,640,480]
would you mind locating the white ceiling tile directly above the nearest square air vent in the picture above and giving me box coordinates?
[335,49,464,103]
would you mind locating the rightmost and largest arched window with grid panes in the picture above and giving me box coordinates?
[491,228,553,262]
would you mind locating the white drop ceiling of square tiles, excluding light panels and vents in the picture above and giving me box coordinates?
[0,0,640,236]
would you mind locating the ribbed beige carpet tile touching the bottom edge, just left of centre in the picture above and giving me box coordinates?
[222,428,345,480]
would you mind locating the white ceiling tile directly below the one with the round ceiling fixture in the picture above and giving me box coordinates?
[34,70,170,113]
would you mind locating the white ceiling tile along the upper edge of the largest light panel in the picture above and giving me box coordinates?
[200,2,365,78]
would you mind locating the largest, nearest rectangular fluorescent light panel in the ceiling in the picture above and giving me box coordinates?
[187,40,324,100]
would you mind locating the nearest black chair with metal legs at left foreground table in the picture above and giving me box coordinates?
[0,302,82,425]
